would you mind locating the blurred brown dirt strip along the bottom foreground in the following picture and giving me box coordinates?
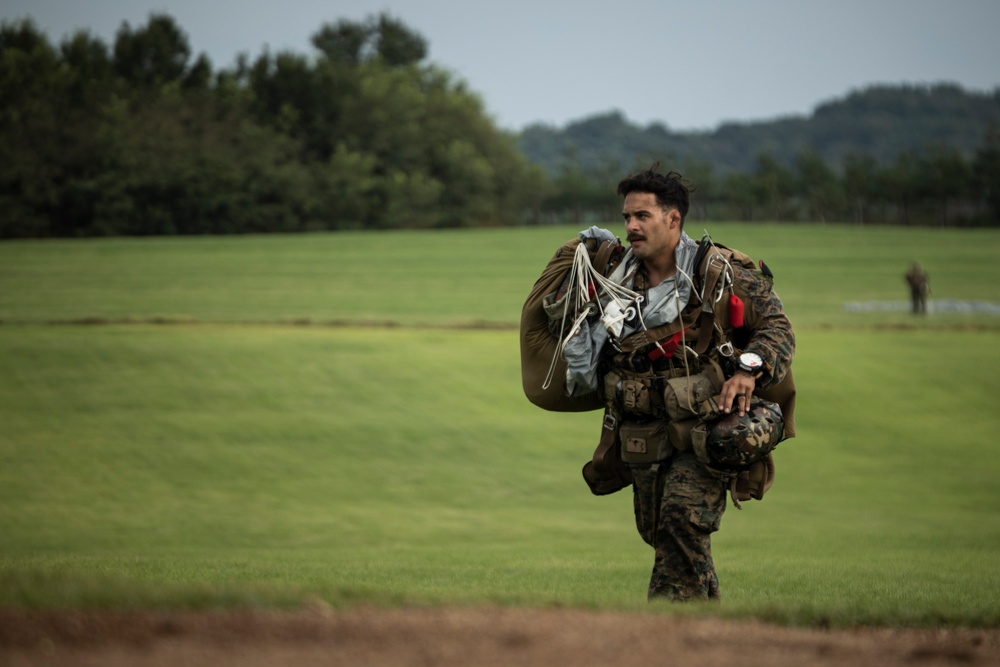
[0,607,1000,667]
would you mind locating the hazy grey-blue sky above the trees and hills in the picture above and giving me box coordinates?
[7,0,1000,130]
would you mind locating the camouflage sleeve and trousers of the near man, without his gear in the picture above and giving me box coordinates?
[606,253,795,601]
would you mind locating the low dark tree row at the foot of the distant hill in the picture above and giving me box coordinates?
[543,133,1000,227]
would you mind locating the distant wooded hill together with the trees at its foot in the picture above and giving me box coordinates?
[520,84,1000,225]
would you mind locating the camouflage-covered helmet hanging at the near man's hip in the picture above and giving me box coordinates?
[694,397,785,472]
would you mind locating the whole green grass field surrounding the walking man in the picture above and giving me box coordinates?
[0,223,1000,626]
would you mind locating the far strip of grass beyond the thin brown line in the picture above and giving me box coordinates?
[0,222,1000,329]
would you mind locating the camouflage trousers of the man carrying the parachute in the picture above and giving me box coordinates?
[632,452,726,601]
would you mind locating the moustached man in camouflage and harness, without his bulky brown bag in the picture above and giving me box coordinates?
[522,165,795,601]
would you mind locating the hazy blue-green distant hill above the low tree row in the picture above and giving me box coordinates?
[519,83,1000,174]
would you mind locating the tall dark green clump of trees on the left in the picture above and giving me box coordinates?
[0,14,546,237]
